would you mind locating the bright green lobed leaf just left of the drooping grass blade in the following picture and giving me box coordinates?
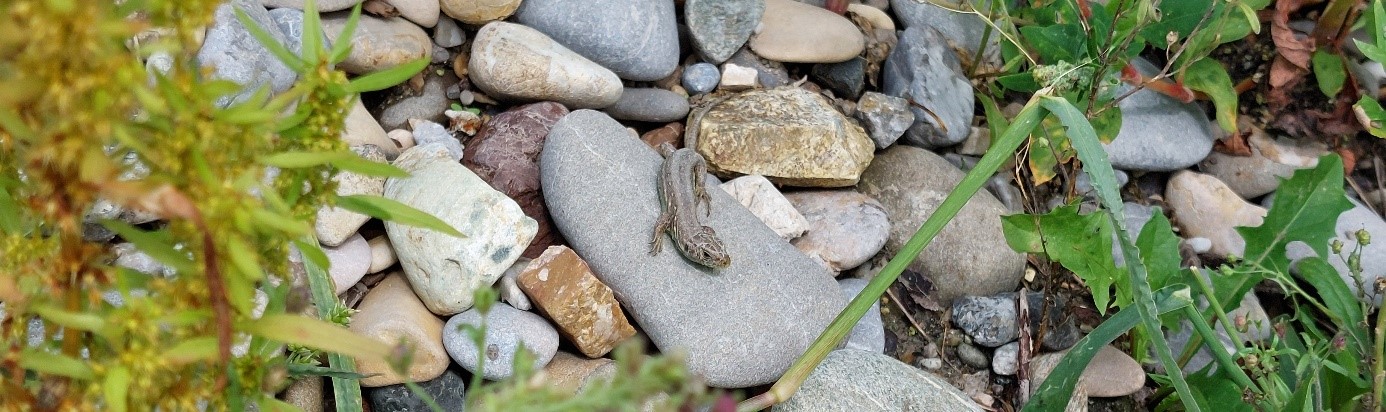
[1001,204,1124,309]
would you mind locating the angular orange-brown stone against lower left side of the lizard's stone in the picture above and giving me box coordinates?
[516,246,635,358]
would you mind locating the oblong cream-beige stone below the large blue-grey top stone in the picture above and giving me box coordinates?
[467,21,621,108]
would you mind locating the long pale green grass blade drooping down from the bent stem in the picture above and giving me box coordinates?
[1041,96,1202,412]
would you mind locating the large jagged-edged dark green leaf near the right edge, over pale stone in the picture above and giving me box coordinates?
[1236,154,1353,273]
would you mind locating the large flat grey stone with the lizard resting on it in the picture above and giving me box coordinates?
[541,111,845,387]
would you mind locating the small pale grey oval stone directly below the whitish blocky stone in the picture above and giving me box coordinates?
[442,302,559,380]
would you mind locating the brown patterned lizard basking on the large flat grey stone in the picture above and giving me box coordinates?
[650,143,732,269]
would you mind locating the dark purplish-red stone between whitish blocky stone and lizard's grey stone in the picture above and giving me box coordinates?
[462,101,568,258]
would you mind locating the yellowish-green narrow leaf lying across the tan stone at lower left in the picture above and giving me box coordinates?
[240,314,394,359]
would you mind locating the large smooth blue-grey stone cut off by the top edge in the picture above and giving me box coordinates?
[516,0,679,81]
